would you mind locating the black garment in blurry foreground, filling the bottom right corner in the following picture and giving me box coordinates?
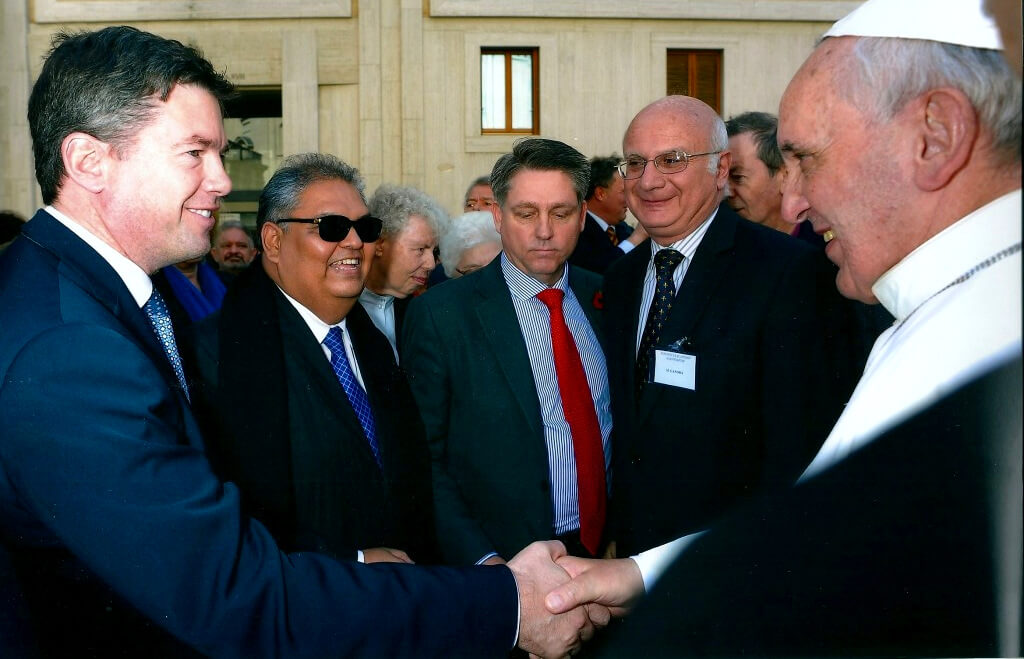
[602,355,1022,657]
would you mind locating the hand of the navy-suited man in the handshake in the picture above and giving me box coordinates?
[508,540,594,657]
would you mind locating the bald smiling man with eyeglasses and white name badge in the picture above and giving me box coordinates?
[604,96,866,560]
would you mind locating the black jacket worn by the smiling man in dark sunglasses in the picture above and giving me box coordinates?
[188,264,435,563]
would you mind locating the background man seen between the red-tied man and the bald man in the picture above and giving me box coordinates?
[569,156,647,273]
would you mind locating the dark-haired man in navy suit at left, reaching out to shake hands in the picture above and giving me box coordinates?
[0,27,591,657]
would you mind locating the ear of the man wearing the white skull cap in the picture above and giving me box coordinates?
[911,88,979,191]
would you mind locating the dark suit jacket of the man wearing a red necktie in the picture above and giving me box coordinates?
[401,258,600,564]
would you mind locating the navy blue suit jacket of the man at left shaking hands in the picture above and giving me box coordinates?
[0,212,518,657]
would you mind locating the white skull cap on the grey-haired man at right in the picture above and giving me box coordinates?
[824,0,1002,50]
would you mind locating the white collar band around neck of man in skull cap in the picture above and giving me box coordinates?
[871,189,1021,320]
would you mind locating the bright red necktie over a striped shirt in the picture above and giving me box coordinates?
[537,289,606,556]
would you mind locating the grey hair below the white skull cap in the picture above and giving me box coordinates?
[841,37,1021,165]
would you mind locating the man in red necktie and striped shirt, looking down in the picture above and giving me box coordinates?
[401,139,611,563]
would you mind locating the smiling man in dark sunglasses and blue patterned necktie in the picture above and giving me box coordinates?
[186,153,434,563]
